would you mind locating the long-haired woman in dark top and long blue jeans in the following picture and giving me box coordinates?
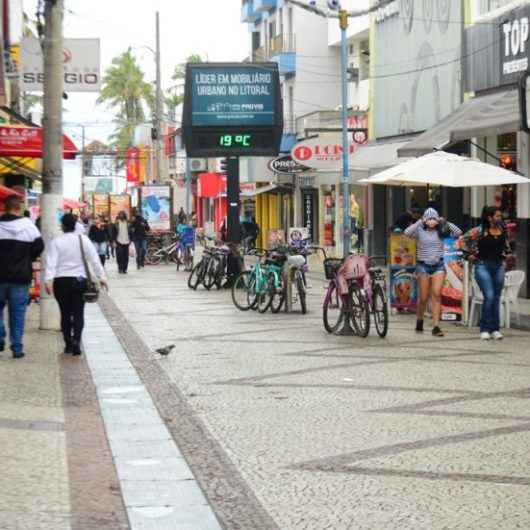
[459,206,511,340]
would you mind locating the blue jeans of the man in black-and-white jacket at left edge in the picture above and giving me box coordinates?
[0,283,29,353]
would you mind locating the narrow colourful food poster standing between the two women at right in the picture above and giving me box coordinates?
[442,238,464,321]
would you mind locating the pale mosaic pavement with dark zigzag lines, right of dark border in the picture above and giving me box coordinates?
[105,267,530,530]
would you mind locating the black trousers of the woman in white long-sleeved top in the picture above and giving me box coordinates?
[53,278,86,346]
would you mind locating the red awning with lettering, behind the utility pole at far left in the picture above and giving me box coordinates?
[0,125,79,160]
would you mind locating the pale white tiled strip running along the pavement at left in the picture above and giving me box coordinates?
[84,306,221,530]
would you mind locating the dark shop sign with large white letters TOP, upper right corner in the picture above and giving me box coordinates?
[500,9,530,78]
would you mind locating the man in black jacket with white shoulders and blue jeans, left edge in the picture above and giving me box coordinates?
[0,196,44,359]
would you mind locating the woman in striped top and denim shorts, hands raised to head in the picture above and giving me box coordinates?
[404,208,462,337]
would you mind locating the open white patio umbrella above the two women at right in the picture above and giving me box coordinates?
[358,151,530,188]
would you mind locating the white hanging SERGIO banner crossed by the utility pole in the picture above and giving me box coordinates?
[21,36,101,93]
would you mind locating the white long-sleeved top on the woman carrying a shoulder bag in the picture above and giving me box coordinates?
[44,232,106,282]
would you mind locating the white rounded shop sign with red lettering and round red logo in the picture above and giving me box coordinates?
[291,135,358,171]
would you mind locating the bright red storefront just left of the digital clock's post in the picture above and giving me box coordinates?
[194,173,227,232]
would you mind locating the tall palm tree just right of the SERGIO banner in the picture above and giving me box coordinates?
[97,48,154,158]
